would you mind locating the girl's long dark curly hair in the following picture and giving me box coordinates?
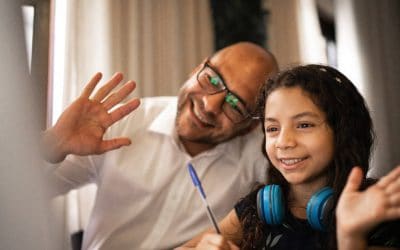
[240,64,375,249]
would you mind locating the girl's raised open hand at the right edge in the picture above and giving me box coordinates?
[336,166,400,240]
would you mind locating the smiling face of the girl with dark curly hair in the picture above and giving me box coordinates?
[264,87,334,187]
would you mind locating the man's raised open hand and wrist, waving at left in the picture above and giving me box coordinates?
[41,73,140,163]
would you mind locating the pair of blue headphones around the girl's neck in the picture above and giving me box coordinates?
[257,184,333,231]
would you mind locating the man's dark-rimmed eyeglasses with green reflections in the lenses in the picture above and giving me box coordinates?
[197,60,255,123]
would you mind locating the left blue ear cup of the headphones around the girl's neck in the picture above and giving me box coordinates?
[257,184,285,225]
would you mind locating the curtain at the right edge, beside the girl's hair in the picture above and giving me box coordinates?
[336,0,400,176]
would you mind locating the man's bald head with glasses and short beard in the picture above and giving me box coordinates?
[176,42,278,155]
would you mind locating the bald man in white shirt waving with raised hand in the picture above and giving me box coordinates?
[43,42,277,249]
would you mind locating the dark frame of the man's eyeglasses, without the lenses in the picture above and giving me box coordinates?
[196,59,258,124]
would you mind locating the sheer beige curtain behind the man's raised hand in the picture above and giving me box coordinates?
[53,0,214,246]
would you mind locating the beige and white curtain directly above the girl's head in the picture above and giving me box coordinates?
[264,0,327,69]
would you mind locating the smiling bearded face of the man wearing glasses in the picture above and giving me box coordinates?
[176,57,261,147]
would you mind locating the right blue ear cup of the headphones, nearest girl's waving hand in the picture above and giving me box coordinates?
[307,187,333,231]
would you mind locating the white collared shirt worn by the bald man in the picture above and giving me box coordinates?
[51,97,267,250]
